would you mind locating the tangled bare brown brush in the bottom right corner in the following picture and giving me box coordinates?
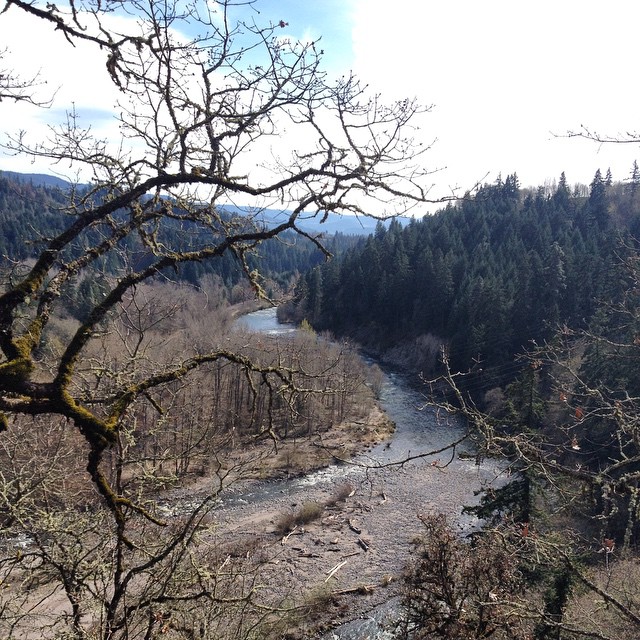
[399,515,639,640]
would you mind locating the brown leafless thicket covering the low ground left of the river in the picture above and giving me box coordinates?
[0,272,392,638]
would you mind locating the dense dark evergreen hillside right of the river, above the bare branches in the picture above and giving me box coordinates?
[293,169,640,383]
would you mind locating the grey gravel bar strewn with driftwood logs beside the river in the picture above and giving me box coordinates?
[181,432,504,639]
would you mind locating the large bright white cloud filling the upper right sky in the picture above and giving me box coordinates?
[353,0,640,189]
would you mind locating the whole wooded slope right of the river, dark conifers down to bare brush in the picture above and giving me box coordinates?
[288,165,640,640]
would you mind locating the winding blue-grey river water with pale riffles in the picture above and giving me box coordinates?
[236,309,508,640]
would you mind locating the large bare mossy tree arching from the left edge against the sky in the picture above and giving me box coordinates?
[0,2,438,514]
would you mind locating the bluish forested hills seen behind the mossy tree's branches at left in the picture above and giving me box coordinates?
[0,173,361,316]
